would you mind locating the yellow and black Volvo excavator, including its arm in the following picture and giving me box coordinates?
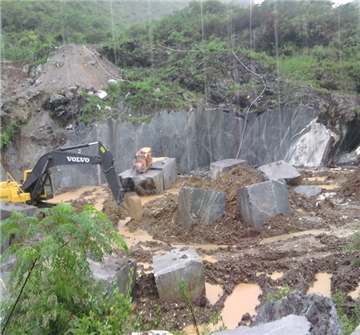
[0,142,128,206]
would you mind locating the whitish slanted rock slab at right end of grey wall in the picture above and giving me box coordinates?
[286,119,334,167]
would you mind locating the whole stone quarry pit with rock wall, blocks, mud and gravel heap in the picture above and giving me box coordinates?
[0,32,360,335]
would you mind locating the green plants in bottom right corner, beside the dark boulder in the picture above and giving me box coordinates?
[333,291,360,335]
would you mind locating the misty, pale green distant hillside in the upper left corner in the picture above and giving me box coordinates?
[0,0,187,63]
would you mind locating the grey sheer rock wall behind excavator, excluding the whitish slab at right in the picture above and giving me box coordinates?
[5,105,317,188]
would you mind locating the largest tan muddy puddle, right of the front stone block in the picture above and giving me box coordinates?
[221,283,262,329]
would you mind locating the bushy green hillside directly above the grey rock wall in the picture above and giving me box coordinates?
[98,0,360,114]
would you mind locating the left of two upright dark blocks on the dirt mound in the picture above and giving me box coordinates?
[176,187,226,226]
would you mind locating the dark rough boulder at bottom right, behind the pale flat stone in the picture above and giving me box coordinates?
[255,292,342,335]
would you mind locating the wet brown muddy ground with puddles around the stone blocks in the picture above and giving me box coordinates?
[48,169,360,334]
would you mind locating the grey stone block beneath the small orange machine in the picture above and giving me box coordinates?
[119,169,164,195]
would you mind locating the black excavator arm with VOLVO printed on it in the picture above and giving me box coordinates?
[22,142,125,205]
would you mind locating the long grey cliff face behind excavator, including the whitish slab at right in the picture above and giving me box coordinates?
[3,90,353,192]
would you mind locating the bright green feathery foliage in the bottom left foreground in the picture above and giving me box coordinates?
[1,204,130,334]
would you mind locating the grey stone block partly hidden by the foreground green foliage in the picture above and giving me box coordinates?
[88,255,136,294]
